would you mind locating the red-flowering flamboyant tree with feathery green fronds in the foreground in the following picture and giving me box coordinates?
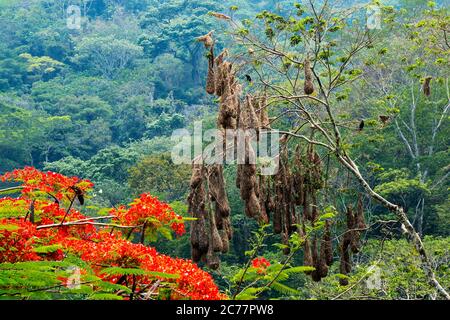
[0,167,226,300]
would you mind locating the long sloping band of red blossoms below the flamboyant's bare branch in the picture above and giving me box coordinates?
[60,232,225,300]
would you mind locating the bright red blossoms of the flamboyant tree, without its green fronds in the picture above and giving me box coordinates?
[0,167,226,300]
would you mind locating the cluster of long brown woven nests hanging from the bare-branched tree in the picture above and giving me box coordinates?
[188,35,365,285]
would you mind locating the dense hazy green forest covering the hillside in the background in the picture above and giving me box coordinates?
[0,0,450,299]
